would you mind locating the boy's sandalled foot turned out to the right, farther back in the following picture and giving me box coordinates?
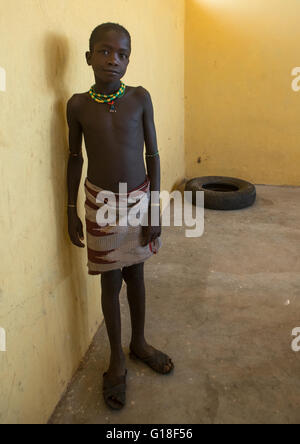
[130,342,174,374]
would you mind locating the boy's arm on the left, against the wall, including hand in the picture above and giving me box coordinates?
[67,95,84,248]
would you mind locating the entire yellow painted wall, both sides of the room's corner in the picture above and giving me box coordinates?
[4,0,300,423]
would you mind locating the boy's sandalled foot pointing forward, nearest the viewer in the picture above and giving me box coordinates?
[103,355,127,409]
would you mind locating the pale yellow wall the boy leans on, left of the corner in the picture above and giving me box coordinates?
[0,0,184,423]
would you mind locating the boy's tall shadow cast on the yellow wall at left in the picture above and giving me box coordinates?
[44,33,89,354]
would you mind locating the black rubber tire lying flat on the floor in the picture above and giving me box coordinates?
[185,176,256,211]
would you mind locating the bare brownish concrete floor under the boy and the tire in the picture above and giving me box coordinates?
[50,185,300,424]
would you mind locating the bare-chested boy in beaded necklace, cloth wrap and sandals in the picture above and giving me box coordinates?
[67,23,174,409]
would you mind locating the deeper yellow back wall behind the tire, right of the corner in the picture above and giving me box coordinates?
[185,0,300,185]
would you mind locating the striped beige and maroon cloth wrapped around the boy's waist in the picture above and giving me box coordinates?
[84,176,162,275]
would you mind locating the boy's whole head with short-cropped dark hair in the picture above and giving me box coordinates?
[86,22,131,81]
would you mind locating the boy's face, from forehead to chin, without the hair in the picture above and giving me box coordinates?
[86,31,130,82]
